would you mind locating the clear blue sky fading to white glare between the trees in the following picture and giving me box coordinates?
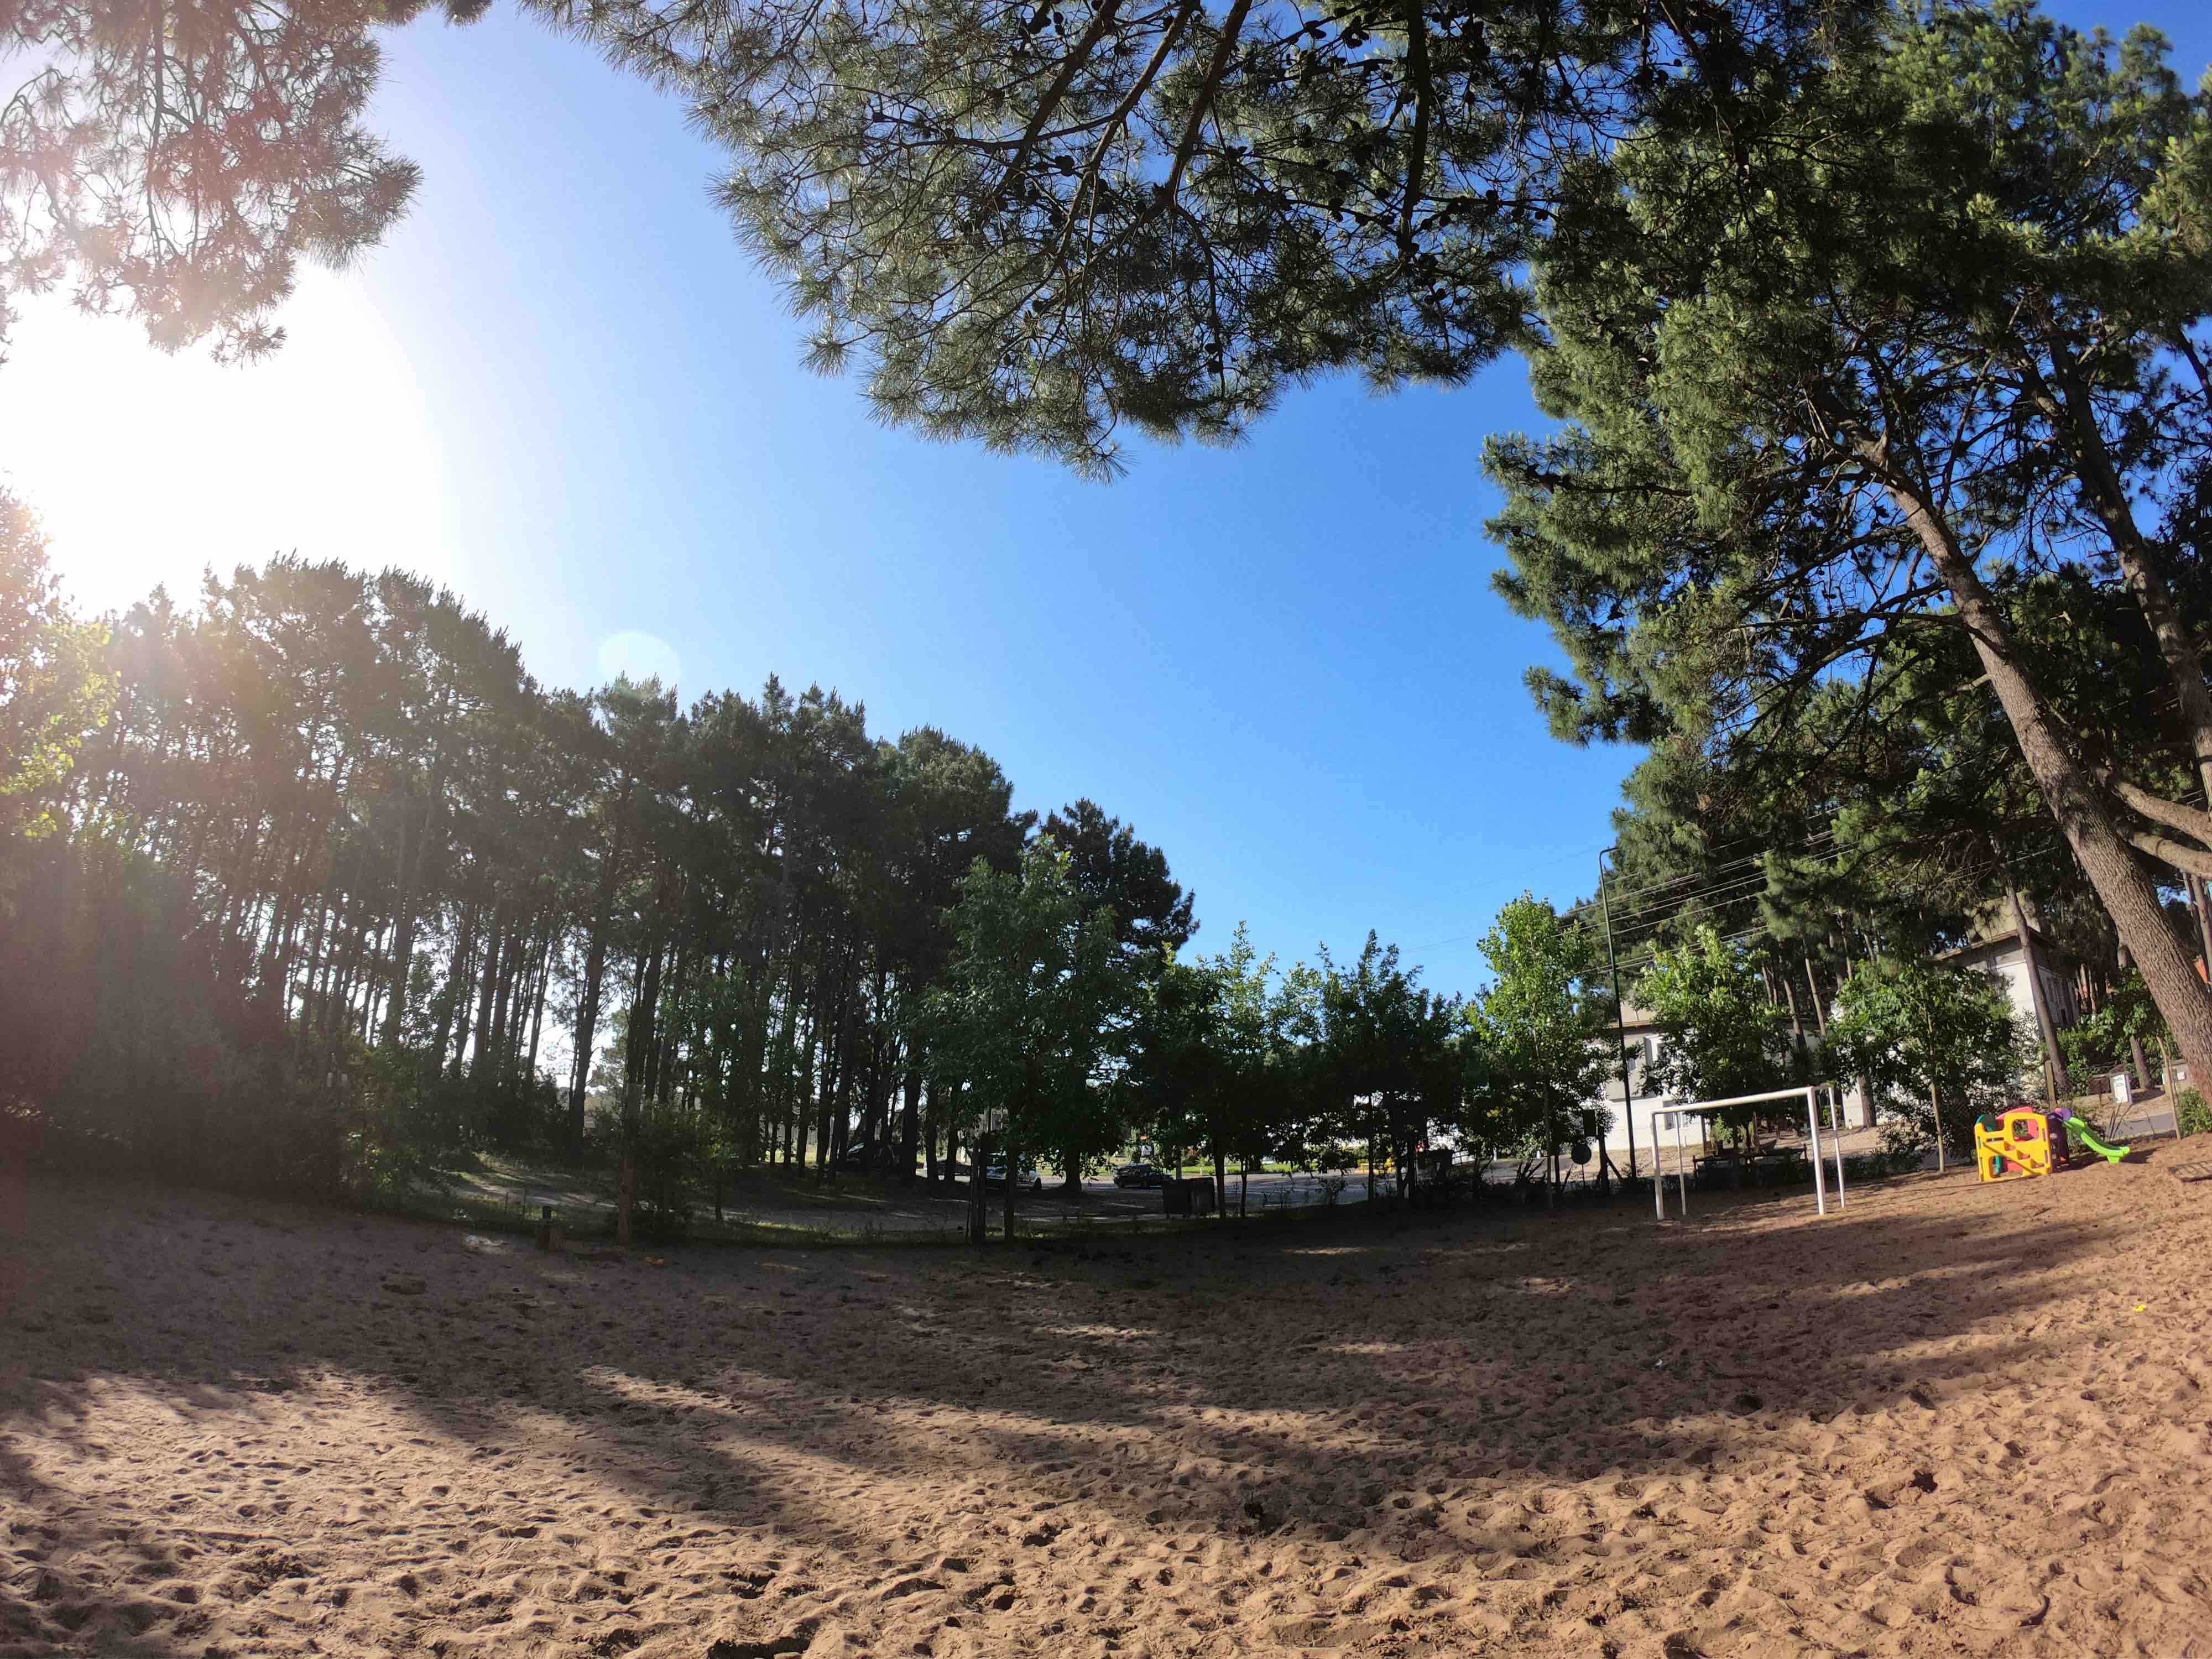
[0,0,2212,989]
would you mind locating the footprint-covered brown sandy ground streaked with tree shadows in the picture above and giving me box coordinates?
[0,1139,2212,1659]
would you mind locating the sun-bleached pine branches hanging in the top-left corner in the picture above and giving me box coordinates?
[0,0,489,356]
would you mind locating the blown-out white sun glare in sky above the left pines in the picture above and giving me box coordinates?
[0,272,451,613]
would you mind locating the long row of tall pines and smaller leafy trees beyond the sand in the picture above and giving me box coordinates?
[0,500,1663,1225]
